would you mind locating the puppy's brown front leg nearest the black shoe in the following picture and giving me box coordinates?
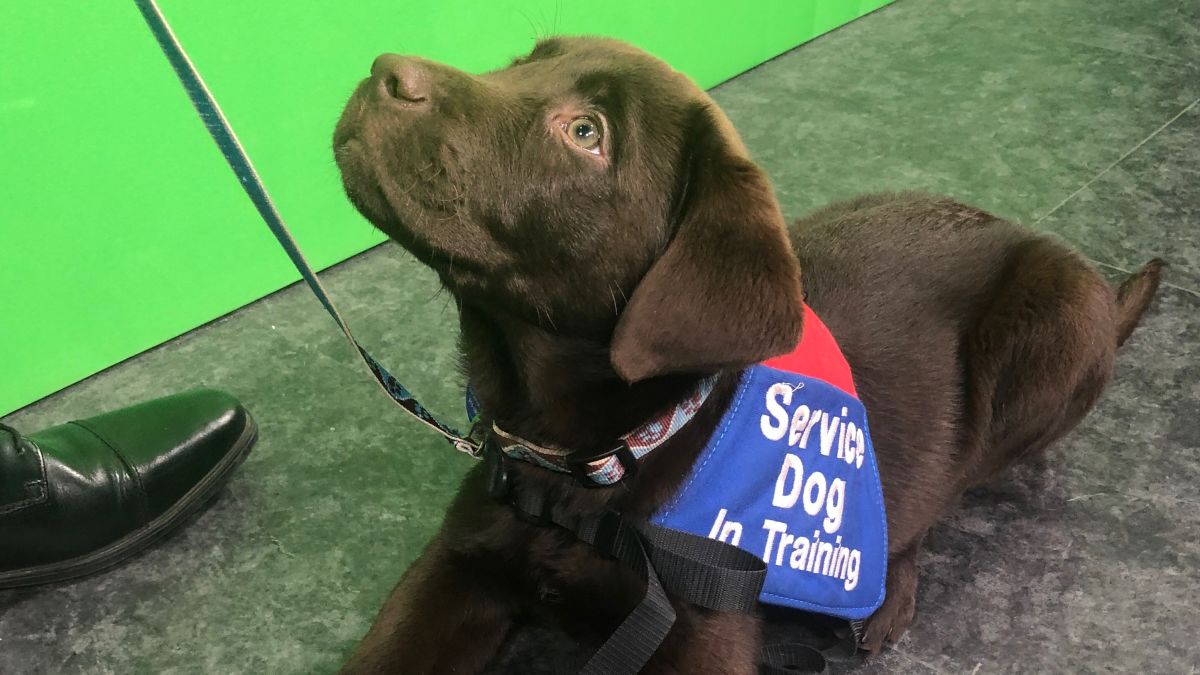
[342,533,515,675]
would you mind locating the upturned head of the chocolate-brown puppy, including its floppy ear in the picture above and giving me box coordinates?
[334,37,803,382]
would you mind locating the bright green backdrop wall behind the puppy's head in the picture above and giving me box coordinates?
[0,0,888,414]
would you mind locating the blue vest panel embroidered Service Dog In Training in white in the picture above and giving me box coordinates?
[652,362,888,620]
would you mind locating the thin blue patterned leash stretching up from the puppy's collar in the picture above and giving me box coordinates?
[133,0,480,458]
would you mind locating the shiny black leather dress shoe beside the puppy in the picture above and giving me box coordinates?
[0,390,258,589]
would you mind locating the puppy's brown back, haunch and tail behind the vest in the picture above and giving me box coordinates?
[791,187,1162,526]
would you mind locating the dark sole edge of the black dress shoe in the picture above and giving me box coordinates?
[0,413,258,591]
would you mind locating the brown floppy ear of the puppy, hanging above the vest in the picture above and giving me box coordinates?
[611,103,804,382]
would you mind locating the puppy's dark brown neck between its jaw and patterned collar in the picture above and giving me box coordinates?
[461,304,701,452]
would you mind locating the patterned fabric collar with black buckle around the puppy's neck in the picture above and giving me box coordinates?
[467,376,718,488]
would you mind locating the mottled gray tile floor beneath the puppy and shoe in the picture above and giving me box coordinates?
[0,0,1200,674]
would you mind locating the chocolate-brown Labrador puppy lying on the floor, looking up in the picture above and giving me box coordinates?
[334,37,1160,674]
